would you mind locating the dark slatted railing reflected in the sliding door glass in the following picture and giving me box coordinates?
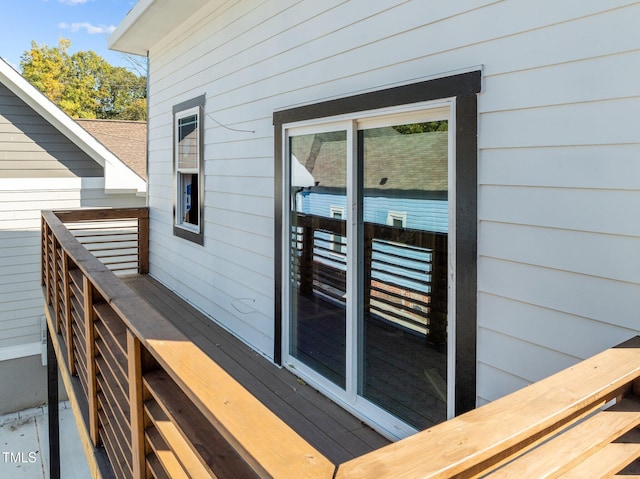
[291,213,448,345]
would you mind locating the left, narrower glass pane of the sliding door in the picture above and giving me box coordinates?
[289,131,349,389]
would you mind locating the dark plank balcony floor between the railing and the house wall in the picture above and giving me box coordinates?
[122,275,389,464]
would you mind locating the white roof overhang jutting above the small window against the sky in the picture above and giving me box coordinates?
[108,0,208,56]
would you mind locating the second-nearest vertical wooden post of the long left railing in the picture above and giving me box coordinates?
[82,275,100,446]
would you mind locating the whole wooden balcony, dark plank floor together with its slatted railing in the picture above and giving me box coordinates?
[42,209,640,479]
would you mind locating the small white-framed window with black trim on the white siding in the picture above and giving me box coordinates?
[173,96,204,244]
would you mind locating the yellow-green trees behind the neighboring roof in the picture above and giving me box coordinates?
[20,39,147,120]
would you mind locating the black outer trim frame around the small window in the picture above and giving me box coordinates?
[172,95,205,245]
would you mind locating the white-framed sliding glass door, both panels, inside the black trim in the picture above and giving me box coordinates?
[284,105,453,437]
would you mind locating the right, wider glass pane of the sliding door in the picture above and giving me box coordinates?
[358,121,449,429]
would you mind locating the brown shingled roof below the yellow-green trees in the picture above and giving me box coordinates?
[76,119,147,180]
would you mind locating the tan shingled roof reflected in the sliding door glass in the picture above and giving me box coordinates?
[291,128,449,196]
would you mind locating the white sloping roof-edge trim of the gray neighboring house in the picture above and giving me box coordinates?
[0,58,147,194]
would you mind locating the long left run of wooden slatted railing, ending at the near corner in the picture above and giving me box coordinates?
[42,210,335,479]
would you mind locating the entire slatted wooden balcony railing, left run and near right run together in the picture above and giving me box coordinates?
[42,207,640,479]
